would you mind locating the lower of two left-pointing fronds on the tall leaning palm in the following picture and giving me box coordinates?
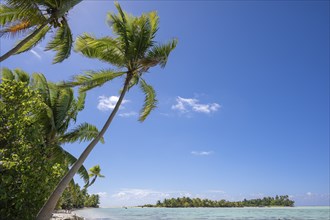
[62,70,126,92]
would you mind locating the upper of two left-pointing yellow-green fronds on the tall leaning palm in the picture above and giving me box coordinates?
[75,33,124,67]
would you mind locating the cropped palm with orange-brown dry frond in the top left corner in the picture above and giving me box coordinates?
[0,0,82,63]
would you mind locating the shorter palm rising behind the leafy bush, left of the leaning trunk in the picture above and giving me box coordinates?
[1,68,103,186]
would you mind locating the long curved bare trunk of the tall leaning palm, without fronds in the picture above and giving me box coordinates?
[36,74,132,220]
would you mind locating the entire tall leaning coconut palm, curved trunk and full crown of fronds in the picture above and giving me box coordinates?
[37,3,177,220]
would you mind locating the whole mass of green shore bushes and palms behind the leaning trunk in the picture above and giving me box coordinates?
[0,69,100,219]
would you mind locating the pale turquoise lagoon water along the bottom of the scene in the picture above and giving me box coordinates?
[75,206,330,220]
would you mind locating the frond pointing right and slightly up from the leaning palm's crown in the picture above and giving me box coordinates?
[141,39,177,68]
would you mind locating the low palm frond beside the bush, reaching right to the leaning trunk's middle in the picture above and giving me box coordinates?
[61,123,104,144]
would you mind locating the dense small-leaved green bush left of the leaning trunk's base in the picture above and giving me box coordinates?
[0,80,64,219]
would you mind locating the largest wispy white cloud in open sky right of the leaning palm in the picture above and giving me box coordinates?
[172,96,221,114]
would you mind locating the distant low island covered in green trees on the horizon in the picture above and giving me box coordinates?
[139,195,294,208]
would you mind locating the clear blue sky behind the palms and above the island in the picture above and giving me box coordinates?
[1,1,329,207]
